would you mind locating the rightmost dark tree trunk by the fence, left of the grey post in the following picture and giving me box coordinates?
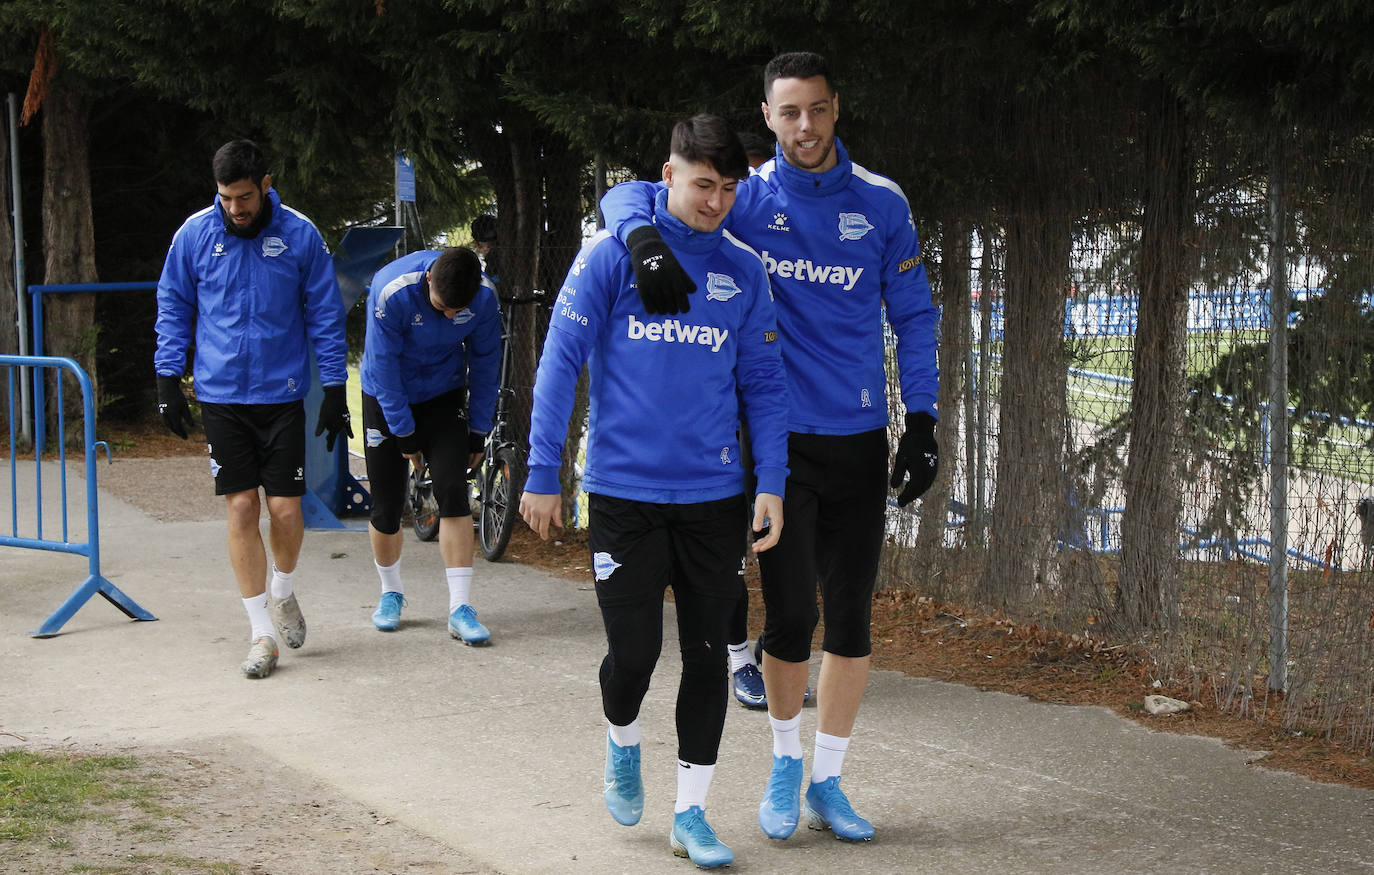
[1117,88,1197,632]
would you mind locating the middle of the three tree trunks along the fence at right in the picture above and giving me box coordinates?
[978,196,1072,607]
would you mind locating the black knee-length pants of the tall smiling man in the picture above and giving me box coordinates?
[758,429,888,662]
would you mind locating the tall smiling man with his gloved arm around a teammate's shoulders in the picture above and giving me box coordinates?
[602,52,938,841]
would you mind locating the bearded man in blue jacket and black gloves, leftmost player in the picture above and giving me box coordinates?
[154,140,353,677]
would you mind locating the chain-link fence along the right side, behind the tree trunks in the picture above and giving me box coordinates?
[883,140,1374,750]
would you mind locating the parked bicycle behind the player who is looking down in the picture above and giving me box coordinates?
[407,293,540,562]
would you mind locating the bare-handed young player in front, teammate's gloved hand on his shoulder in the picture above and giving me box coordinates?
[521,115,787,868]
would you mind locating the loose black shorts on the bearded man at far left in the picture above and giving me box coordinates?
[201,401,305,497]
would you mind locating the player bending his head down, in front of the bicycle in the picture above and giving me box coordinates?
[359,247,502,644]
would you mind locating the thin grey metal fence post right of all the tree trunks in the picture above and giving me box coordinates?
[1268,128,1289,692]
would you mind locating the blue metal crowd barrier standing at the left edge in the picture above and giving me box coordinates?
[0,356,157,637]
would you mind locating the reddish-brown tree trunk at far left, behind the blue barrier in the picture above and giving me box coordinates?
[43,77,100,431]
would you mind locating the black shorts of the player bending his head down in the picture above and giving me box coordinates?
[363,389,473,534]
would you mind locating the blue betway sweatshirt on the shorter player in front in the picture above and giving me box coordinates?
[526,191,787,504]
